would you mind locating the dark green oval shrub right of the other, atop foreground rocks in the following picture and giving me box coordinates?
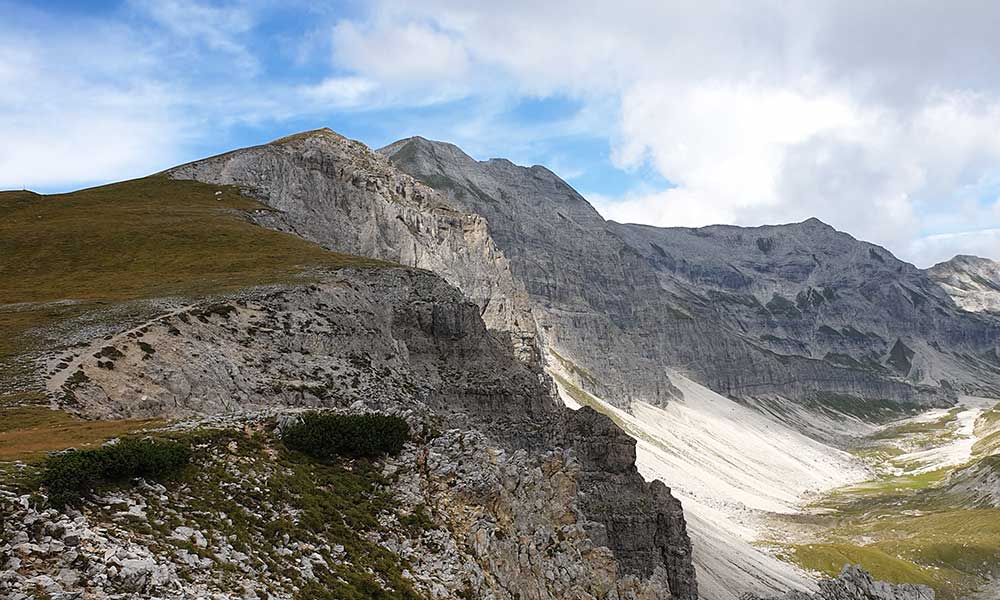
[281,412,410,459]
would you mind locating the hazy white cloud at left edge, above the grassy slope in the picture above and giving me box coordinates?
[0,28,189,189]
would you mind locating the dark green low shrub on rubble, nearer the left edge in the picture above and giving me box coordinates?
[41,438,191,506]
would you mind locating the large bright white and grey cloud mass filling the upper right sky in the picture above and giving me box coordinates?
[328,0,1000,262]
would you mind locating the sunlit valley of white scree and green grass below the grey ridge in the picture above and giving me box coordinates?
[552,358,1000,600]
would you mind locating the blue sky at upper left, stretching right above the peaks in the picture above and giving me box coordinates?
[0,1,652,196]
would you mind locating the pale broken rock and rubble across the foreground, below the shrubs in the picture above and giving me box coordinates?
[0,418,680,600]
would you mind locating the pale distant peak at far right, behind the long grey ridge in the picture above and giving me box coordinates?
[927,255,1000,314]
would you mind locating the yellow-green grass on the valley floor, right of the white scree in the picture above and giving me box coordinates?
[788,404,1000,600]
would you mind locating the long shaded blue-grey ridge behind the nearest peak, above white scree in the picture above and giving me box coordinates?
[381,138,1000,416]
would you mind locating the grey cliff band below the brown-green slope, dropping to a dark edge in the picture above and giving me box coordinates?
[55,267,697,600]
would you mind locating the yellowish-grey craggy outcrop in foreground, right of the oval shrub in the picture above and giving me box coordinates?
[386,430,670,600]
